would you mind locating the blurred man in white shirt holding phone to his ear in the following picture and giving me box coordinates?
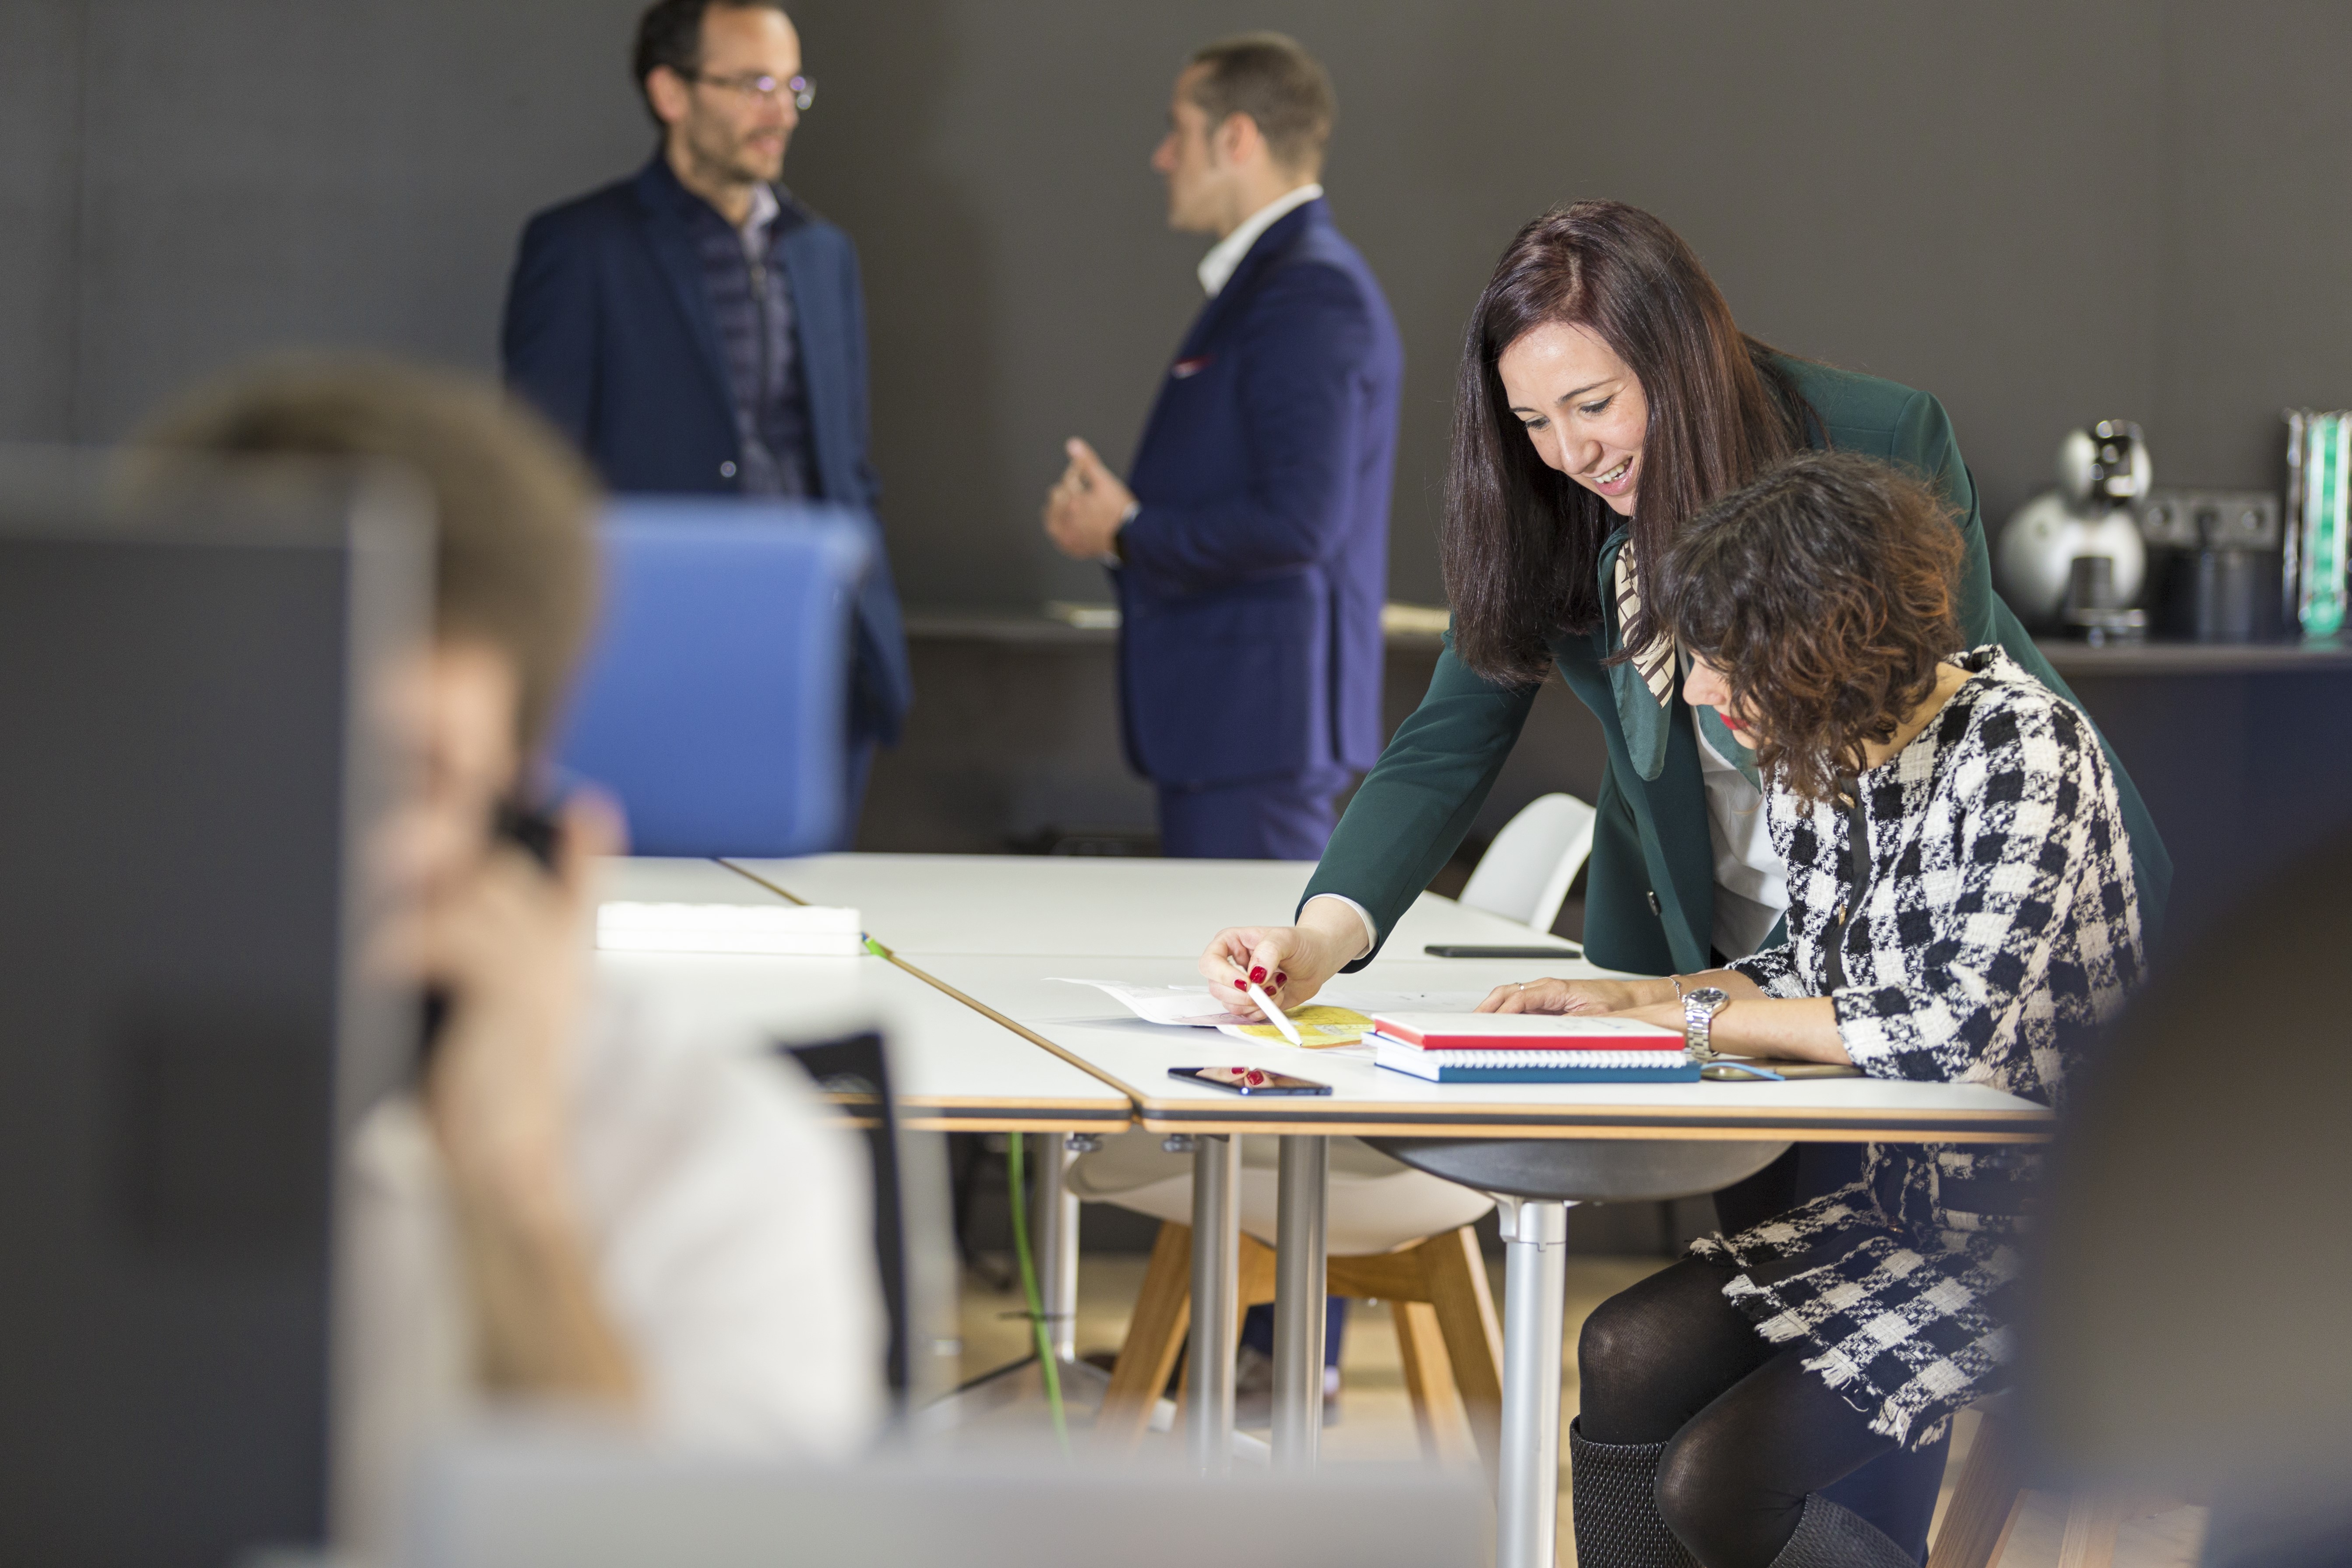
[146,359,884,1544]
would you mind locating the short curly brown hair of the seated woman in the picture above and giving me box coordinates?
[1654,451,1961,802]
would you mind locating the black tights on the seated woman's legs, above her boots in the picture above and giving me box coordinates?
[1576,1258,1894,1568]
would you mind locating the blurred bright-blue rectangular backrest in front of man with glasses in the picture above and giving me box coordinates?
[557,498,873,856]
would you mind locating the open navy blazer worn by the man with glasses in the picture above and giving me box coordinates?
[501,153,913,740]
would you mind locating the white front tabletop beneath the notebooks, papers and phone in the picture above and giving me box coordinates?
[922,955,2051,1142]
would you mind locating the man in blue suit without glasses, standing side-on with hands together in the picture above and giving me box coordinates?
[1044,33,1404,860]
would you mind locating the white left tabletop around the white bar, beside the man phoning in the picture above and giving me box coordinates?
[597,860,1131,1133]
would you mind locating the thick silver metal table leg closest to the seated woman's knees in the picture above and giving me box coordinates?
[1494,1199,1569,1568]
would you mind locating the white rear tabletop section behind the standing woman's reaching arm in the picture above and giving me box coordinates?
[734,856,1580,959]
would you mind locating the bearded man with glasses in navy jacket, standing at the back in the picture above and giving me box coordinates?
[503,0,913,846]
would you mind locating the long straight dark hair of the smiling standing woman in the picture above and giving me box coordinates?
[1439,202,1809,682]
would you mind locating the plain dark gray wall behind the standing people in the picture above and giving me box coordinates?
[0,0,2352,604]
